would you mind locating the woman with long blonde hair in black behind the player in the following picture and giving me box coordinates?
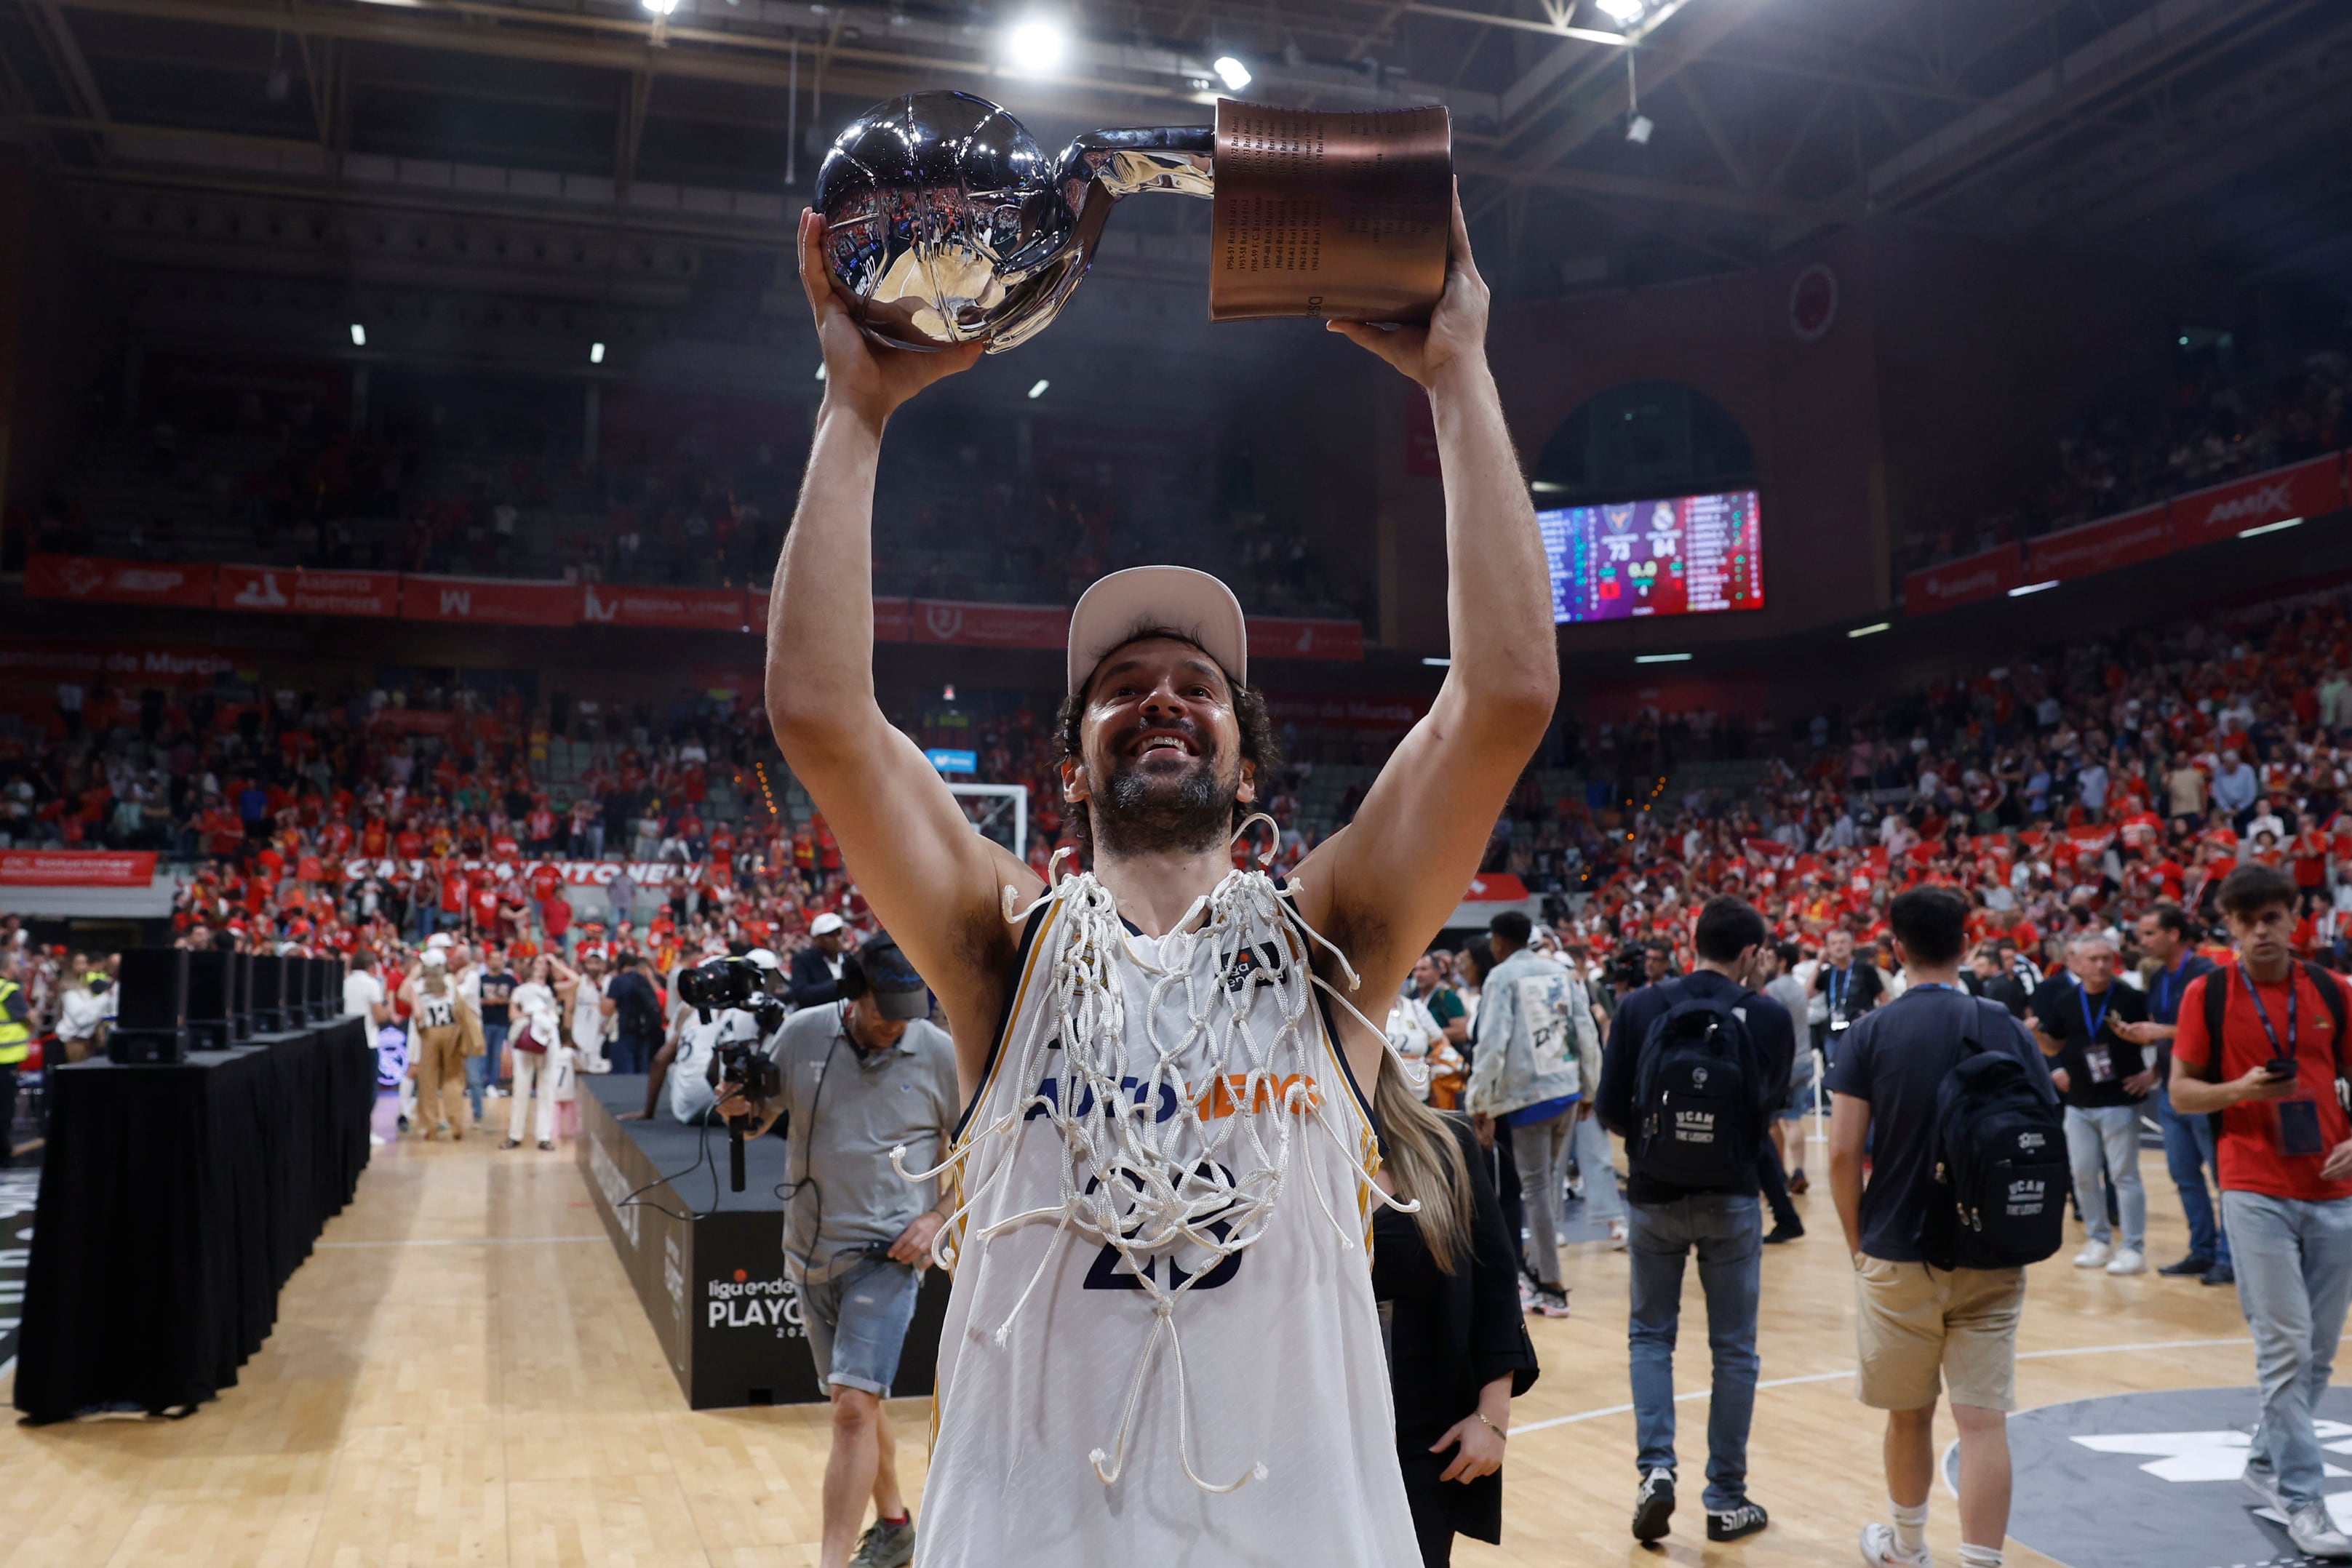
[1371,1053,1536,1568]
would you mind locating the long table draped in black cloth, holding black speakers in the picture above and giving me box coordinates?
[17,1018,376,1423]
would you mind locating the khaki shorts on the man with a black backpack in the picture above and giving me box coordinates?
[1854,1257,2025,1410]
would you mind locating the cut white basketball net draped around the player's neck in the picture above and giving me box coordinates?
[891,818,1425,1493]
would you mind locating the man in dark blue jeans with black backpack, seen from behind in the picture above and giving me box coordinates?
[1599,898,1797,1542]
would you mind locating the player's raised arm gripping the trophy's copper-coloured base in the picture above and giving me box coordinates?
[1299,198,1559,997]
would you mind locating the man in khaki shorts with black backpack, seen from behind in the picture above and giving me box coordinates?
[1830,889,2070,1568]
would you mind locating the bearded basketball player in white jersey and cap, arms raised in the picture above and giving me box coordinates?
[767,207,1559,1568]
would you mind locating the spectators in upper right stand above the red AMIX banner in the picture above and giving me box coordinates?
[1900,351,2352,571]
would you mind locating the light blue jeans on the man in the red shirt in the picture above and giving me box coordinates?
[2220,1192,2352,1507]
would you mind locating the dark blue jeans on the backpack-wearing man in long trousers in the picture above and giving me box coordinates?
[1625,1192,1764,1511]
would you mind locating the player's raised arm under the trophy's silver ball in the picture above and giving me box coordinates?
[767,212,1040,1063]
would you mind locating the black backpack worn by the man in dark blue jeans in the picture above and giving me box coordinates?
[1627,980,1764,1187]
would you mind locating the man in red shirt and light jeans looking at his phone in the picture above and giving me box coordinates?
[2171,865,2352,1559]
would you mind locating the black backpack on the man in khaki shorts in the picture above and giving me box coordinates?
[1921,999,2075,1269]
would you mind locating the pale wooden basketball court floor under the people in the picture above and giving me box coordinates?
[0,1135,2253,1568]
